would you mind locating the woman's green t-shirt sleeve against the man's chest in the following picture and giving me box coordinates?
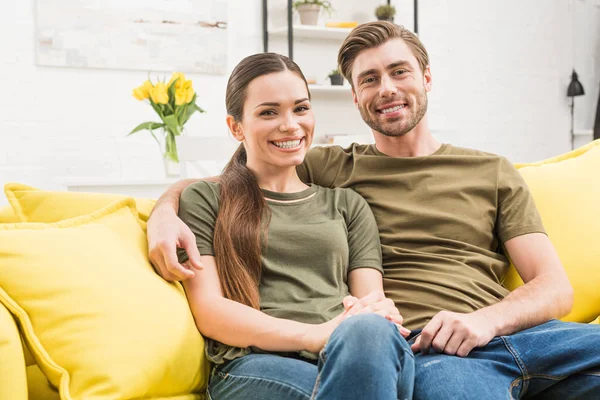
[344,189,383,274]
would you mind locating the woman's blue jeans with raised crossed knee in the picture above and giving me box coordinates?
[208,314,415,400]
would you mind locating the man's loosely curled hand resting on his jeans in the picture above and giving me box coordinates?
[411,311,495,357]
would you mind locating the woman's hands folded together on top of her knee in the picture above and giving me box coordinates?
[343,290,410,337]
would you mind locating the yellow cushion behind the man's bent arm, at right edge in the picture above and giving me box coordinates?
[505,140,600,322]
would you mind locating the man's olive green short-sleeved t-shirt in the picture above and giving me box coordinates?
[298,144,544,329]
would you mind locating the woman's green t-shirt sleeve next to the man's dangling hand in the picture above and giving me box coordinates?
[177,181,219,263]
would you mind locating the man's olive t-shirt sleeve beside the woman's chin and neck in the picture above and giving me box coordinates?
[296,146,346,188]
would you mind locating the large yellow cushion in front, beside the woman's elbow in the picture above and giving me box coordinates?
[0,199,208,400]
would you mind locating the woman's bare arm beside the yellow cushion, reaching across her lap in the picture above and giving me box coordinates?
[182,256,344,353]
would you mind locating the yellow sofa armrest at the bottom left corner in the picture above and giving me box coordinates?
[0,304,27,400]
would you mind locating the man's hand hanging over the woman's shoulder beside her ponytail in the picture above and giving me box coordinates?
[147,206,202,282]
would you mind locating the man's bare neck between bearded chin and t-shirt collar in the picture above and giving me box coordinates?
[373,119,441,157]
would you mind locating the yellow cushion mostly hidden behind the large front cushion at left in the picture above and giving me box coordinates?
[5,183,156,222]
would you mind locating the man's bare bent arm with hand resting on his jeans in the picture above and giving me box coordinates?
[412,233,573,357]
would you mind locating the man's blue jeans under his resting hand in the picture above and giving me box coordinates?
[409,320,600,400]
